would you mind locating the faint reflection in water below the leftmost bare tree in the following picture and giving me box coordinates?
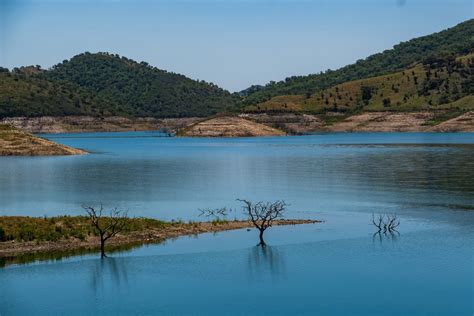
[91,257,128,291]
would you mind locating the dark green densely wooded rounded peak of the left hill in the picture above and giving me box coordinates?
[41,53,235,117]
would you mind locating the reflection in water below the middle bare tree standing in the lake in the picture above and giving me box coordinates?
[248,245,285,279]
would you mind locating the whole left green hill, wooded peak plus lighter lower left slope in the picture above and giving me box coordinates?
[0,53,236,118]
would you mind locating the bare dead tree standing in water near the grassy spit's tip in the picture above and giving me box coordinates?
[237,199,288,246]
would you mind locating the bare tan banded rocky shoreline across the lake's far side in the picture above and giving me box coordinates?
[0,111,474,137]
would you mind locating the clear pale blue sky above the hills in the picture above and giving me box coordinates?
[0,0,474,91]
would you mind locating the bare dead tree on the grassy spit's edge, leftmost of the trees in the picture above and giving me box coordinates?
[82,204,128,258]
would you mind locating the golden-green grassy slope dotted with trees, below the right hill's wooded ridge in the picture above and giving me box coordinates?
[244,54,474,114]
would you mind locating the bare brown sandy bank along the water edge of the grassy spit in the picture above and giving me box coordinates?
[0,219,319,258]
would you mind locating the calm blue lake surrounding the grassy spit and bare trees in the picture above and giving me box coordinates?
[0,132,474,315]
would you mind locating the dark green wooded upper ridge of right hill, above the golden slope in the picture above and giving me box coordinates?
[242,19,474,106]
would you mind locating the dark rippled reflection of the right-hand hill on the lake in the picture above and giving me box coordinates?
[312,144,474,193]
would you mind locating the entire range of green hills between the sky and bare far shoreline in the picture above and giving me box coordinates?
[0,20,474,118]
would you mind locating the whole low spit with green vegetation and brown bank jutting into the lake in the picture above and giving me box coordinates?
[0,216,321,262]
